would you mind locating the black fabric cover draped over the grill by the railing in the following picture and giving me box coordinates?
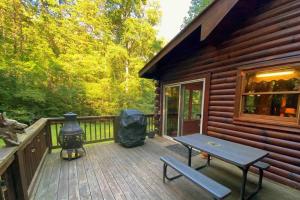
[118,110,147,147]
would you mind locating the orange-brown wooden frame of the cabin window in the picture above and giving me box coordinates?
[234,65,300,128]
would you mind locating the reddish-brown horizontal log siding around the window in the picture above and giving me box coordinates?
[160,0,300,189]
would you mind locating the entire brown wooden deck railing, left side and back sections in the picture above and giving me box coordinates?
[0,115,154,200]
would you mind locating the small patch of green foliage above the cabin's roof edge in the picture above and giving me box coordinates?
[181,0,214,28]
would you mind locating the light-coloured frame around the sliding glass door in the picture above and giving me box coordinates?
[162,77,209,138]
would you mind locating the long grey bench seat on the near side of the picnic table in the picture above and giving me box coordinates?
[160,156,231,199]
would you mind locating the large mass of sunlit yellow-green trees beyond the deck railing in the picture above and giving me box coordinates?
[0,0,162,123]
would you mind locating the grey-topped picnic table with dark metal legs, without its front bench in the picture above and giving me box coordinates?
[174,133,268,200]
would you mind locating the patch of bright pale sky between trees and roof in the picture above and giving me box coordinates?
[158,0,191,42]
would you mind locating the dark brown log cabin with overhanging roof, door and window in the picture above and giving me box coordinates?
[139,0,300,189]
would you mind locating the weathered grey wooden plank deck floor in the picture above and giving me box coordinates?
[33,137,299,200]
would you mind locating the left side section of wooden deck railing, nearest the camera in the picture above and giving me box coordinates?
[0,118,50,200]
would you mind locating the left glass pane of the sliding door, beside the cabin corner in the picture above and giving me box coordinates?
[164,86,180,137]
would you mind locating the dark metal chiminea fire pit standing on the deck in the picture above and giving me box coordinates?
[59,112,85,160]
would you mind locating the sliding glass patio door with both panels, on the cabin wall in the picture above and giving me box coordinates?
[163,79,204,137]
